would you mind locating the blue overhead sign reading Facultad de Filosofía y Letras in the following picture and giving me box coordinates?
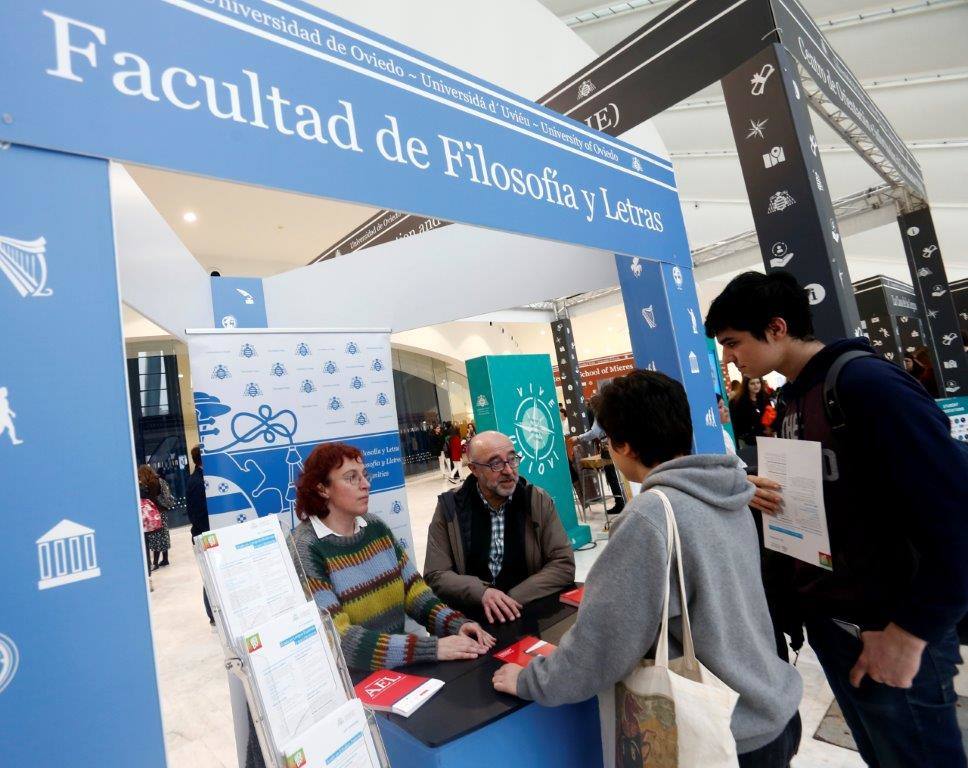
[0,0,690,265]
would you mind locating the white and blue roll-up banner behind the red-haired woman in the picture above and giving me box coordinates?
[188,331,414,558]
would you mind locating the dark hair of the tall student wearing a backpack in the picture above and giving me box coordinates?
[706,272,813,341]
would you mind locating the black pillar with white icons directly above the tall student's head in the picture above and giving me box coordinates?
[722,43,860,341]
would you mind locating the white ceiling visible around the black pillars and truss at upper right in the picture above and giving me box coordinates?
[540,0,968,294]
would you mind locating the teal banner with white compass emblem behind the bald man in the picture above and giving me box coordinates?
[467,355,591,548]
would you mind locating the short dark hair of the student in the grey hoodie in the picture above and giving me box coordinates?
[597,371,692,467]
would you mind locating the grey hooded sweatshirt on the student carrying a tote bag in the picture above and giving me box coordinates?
[517,455,803,754]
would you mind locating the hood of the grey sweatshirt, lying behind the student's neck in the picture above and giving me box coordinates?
[642,454,756,512]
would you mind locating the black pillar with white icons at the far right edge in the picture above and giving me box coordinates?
[897,207,968,397]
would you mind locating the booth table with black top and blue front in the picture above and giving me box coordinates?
[353,594,602,768]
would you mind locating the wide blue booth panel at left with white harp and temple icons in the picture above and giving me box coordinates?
[0,145,165,768]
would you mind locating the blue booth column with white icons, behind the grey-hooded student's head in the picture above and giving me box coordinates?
[615,254,725,453]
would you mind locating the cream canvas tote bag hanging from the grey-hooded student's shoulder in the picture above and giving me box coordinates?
[598,488,739,768]
